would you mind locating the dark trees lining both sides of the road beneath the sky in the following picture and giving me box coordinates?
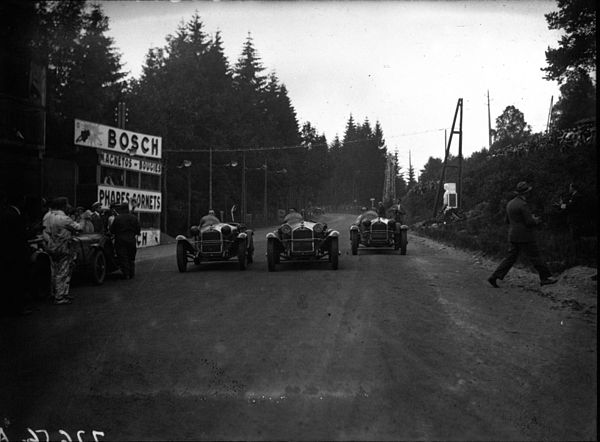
[2,0,596,250]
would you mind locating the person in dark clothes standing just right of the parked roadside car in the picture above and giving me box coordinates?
[110,203,141,279]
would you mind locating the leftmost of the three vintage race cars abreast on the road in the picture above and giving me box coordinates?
[176,223,254,272]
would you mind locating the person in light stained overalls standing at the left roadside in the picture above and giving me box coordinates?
[44,197,81,305]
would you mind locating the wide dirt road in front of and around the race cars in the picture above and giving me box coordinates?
[0,215,597,441]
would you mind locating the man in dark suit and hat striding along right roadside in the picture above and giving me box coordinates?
[488,181,556,288]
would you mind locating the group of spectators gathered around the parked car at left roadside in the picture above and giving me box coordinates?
[0,196,141,314]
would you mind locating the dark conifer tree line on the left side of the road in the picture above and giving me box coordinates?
[7,0,403,233]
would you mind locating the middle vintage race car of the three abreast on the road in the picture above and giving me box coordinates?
[267,218,340,272]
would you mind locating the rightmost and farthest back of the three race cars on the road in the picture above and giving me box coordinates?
[350,210,408,255]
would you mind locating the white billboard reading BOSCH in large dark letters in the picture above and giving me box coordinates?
[73,120,162,159]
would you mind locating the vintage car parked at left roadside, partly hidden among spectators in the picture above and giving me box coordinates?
[72,233,119,285]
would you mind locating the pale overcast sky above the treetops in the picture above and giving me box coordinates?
[99,0,561,176]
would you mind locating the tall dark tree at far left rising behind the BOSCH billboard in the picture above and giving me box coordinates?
[32,1,126,147]
